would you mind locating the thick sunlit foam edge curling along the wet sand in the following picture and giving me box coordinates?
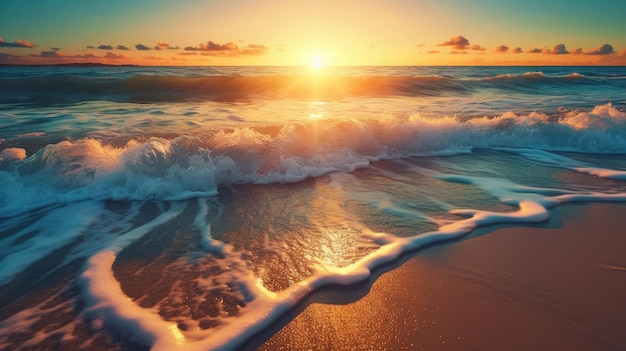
[72,182,604,350]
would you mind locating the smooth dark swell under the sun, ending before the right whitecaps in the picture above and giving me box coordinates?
[0,75,465,103]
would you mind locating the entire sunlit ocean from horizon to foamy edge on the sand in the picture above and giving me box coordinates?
[0,66,626,350]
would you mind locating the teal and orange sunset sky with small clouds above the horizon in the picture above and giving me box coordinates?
[0,0,626,66]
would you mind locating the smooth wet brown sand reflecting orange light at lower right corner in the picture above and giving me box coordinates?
[248,203,626,350]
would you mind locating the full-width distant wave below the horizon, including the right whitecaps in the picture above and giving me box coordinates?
[0,72,626,104]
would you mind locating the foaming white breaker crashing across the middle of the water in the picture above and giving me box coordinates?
[0,104,626,216]
